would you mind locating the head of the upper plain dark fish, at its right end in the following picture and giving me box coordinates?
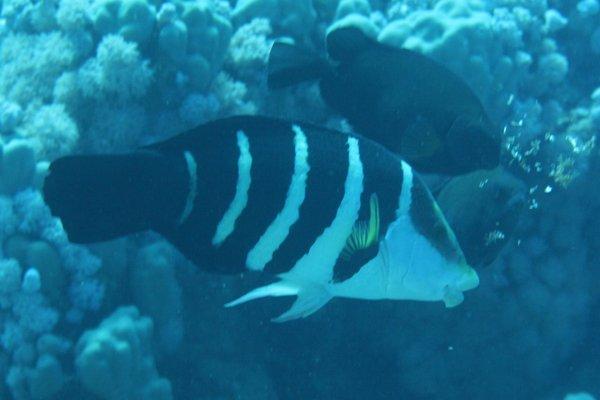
[446,113,500,173]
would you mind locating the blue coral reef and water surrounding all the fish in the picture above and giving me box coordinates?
[0,0,600,400]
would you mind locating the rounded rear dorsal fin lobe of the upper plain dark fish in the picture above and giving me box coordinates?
[326,26,376,62]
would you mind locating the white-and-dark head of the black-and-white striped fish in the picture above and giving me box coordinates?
[380,173,479,307]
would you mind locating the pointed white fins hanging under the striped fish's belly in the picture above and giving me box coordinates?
[225,280,332,322]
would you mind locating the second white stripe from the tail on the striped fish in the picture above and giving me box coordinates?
[212,131,252,246]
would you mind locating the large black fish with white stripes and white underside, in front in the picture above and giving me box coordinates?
[44,117,478,321]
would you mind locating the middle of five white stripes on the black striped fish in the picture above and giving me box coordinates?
[246,125,310,271]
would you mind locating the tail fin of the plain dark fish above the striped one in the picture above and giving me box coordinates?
[267,42,329,89]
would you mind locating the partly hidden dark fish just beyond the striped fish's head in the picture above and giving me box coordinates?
[436,168,527,268]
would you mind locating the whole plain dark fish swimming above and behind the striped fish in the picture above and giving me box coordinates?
[268,27,500,175]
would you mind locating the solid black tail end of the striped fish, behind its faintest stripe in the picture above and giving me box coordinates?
[43,150,187,243]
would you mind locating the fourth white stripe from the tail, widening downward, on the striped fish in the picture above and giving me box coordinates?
[280,137,364,283]
